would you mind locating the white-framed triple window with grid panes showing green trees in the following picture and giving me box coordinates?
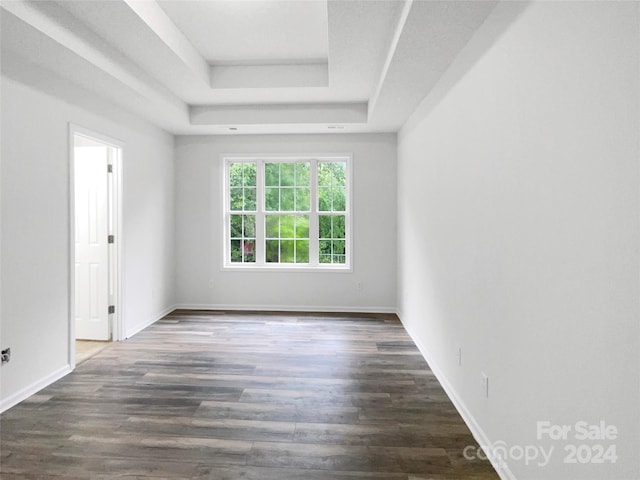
[224,155,351,269]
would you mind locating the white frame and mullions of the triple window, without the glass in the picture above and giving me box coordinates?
[220,153,353,272]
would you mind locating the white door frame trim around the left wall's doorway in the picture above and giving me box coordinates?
[68,123,124,370]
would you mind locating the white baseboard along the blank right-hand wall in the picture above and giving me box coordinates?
[397,312,517,480]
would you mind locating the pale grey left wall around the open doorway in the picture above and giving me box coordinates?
[0,76,174,409]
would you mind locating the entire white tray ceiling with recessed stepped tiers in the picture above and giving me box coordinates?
[0,0,496,135]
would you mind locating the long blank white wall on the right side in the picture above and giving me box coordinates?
[398,2,640,480]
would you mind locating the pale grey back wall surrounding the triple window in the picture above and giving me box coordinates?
[176,134,396,311]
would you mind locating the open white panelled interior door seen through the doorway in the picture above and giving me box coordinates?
[74,141,111,340]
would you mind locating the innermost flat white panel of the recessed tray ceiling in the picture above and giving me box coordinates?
[157,0,329,65]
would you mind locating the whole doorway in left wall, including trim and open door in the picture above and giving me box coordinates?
[69,125,122,368]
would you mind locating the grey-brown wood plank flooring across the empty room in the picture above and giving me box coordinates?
[0,311,498,480]
